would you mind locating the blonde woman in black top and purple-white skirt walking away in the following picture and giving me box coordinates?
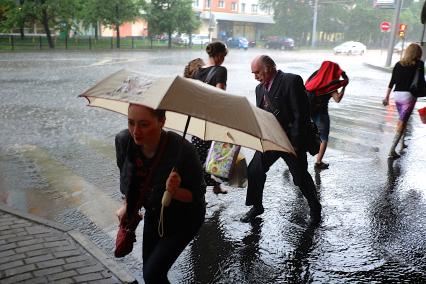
[383,43,425,159]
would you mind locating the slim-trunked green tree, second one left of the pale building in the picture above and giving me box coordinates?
[97,0,144,48]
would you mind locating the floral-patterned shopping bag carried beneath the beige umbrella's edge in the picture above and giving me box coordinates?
[205,141,241,179]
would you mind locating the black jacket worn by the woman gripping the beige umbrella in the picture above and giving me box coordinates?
[115,129,206,232]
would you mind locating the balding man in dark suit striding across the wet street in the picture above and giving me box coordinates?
[241,55,321,222]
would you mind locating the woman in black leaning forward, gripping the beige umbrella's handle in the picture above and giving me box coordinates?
[115,104,206,283]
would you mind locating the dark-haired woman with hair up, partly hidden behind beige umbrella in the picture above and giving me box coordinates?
[191,41,228,194]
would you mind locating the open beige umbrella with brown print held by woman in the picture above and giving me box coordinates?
[79,70,295,155]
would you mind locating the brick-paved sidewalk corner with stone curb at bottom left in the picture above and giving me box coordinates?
[0,204,136,284]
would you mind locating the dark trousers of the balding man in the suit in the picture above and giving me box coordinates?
[246,151,321,213]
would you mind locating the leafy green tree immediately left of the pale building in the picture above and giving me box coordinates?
[145,0,200,48]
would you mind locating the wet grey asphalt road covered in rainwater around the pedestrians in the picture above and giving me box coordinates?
[0,50,426,283]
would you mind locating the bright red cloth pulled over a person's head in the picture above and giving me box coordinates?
[305,61,349,96]
